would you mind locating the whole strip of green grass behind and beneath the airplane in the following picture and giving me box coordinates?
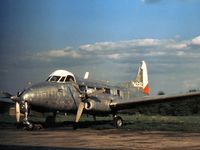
[0,114,200,132]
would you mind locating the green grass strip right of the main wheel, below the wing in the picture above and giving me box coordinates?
[123,115,200,132]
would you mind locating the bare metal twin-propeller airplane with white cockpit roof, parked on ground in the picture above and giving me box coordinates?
[1,61,200,129]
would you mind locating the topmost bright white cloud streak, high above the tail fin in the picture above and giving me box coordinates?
[80,38,191,53]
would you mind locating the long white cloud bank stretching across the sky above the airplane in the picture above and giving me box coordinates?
[32,36,200,63]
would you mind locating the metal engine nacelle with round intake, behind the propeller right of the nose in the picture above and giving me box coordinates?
[85,99,111,112]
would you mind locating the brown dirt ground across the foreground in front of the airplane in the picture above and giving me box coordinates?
[0,128,200,150]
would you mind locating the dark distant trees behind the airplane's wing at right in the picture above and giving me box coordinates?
[124,90,200,116]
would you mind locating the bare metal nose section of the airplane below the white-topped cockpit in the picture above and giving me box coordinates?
[24,82,81,112]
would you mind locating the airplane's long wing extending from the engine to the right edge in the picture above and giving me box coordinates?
[110,92,200,111]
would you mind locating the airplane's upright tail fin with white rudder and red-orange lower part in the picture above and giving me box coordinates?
[132,61,149,95]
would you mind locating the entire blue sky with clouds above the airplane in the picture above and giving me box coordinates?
[0,0,200,94]
